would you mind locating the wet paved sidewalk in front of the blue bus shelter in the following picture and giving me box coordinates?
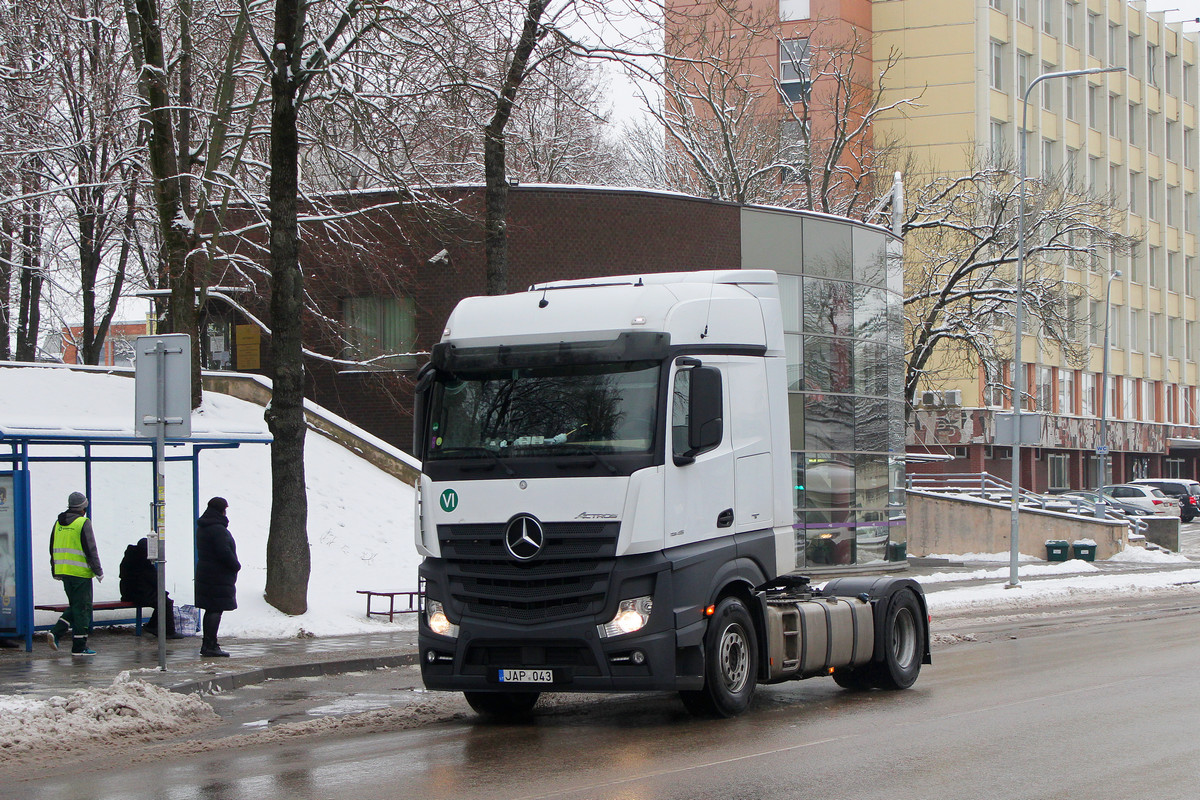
[0,625,416,699]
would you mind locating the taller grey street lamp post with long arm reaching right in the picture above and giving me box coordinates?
[1007,67,1124,589]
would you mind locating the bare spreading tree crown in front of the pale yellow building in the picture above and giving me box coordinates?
[904,160,1135,417]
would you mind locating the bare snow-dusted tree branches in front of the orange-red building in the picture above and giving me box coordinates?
[630,2,917,216]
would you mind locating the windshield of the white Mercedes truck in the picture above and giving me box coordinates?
[426,361,660,461]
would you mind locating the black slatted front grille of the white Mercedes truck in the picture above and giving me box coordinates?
[438,522,619,622]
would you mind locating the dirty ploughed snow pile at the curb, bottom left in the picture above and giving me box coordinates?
[0,672,220,763]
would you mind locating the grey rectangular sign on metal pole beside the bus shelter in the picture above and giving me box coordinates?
[133,333,192,672]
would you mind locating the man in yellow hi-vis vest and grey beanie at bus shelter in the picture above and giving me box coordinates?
[49,492,104,656]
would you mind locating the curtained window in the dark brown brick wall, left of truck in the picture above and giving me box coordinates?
[342,297,416,369]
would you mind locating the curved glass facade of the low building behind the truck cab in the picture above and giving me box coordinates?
[742,209,906,569]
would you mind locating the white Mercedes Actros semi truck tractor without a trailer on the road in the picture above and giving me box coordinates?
[414,270,930,716]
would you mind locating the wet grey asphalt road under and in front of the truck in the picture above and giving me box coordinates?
[20,599,1200,800]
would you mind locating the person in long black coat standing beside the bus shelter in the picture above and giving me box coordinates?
[196,498,241,658]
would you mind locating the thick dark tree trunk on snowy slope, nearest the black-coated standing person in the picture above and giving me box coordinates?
[265,0,311,614]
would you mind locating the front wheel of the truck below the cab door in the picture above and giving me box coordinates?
[679,597,758,717]
